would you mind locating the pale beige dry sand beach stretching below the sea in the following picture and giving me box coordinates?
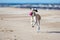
[0,7,60,40]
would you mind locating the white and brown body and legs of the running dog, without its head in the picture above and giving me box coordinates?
[31,11,41,30]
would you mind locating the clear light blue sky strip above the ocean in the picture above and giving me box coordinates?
[0,0,60,3]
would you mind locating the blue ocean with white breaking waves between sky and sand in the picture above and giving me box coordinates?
[0,3,60,10]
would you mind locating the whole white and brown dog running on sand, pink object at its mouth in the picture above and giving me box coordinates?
[29,9,41,31]
